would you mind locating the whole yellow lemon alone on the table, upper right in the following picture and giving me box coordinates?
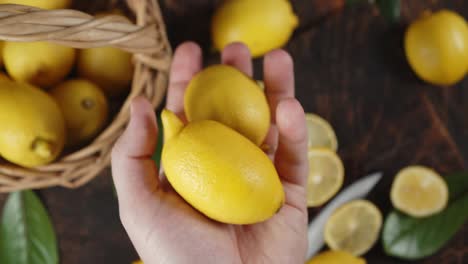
[405,10,468,85]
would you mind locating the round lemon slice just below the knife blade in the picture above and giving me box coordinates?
[324,200,382,256]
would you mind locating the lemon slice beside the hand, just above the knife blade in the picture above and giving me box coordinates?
[307,149,344,207]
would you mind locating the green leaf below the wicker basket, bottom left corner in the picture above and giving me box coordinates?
[0,191,58,264]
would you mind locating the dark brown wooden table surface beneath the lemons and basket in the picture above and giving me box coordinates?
[0,0,468,264]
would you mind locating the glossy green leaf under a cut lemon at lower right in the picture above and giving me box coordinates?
[382,173,468,260]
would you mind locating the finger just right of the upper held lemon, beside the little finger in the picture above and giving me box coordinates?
[263,50,294,122]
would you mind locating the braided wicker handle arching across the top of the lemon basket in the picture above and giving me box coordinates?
[0,1,170,71]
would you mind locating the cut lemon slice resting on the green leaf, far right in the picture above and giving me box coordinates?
[390,166,449,217]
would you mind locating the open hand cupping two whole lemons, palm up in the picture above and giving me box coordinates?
[112,43,308,264]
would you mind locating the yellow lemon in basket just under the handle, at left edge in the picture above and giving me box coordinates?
[3,42,75,88]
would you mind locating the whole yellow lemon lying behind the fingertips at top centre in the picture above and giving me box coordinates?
[211,0,299,57]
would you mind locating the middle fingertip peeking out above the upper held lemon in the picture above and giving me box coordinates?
[221,42,253,77]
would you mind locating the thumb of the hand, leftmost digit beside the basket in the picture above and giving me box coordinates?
[111,97,158,208]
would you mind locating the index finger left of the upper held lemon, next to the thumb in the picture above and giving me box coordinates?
[166,42,202,119]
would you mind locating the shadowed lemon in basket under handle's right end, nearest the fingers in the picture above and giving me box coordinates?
[78,47,133,96]
